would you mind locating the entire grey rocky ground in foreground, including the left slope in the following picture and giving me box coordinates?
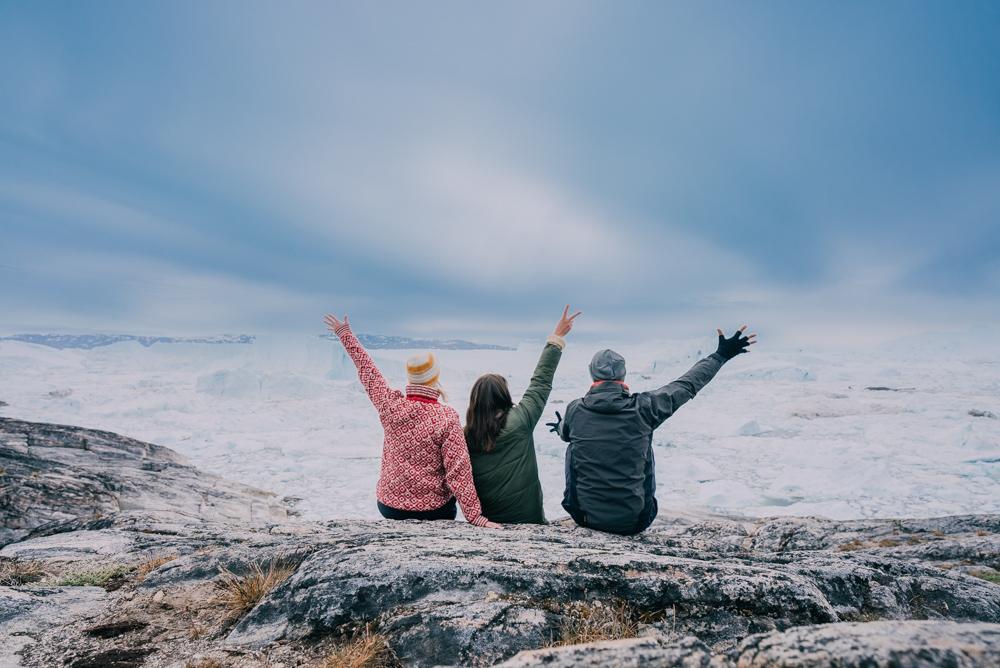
[0,421,1000,668]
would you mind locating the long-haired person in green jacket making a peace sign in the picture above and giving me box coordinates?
[465,305,581,524]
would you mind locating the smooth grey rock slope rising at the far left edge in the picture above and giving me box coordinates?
[0,418,289,545]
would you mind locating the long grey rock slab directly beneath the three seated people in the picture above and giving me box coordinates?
[230,523,1000,663]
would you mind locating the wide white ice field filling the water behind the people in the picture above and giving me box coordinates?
[0,335,1000,519]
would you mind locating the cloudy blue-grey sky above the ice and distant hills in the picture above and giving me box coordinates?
[0,0,1000,350]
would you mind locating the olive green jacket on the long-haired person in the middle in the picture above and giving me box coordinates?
[469,342,562,524]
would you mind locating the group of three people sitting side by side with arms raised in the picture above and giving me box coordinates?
[325,306,756,535]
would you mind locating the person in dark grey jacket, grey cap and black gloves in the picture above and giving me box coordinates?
[552,325,757,535]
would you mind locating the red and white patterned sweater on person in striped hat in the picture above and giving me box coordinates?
[336,324,487,526]
